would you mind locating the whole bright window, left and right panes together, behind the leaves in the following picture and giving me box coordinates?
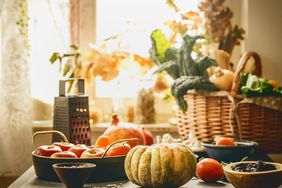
[29,0,198,120]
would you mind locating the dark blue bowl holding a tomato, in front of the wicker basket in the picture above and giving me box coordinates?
[202,141,258,163]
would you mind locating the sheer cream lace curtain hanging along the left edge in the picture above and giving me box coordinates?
[0,0,32,175]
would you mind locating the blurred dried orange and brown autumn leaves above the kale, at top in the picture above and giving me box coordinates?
[165,0,245,56]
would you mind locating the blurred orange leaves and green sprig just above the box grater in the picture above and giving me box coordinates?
[50,42,156,92]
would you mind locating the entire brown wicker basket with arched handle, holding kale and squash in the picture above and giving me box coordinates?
[177,52,282,153]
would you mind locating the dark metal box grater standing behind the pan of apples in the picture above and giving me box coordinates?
[52,79,91,145]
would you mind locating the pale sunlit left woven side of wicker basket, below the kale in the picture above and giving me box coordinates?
[177,91,239,141]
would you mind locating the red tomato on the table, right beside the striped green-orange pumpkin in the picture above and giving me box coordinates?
[196,158,224,182]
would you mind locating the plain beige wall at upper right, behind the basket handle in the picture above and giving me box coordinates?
[242,0,282,84]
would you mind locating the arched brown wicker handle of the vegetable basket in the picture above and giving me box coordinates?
[231,51,262,97]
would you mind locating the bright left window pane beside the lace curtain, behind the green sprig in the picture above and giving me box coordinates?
[29,0,70,103]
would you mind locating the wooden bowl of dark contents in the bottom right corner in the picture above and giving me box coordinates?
[223,161,282,188]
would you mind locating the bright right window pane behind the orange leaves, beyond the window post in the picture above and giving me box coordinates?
[96,0,198,97]
